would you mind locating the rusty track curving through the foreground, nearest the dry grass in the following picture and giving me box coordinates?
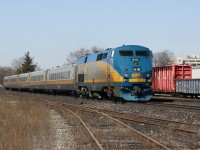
[43,102,169,150]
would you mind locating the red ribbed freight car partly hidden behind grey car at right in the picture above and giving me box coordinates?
[152,64,192,94]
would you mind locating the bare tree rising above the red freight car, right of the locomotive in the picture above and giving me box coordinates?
[153,50,174,66]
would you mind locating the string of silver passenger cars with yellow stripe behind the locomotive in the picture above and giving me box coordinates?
[3,66,76,92]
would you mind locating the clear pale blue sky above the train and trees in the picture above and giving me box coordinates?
[0,0,200,69]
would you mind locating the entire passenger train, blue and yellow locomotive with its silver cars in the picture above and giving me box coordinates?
[3,45,153,101]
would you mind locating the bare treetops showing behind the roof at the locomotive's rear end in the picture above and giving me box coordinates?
[64,46,103,65]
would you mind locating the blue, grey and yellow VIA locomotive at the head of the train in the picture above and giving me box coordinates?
[76,45,152,101]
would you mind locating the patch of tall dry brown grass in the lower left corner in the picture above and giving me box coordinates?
[0,97,50,150]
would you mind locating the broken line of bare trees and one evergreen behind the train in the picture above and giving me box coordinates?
[0,46,174,84]
